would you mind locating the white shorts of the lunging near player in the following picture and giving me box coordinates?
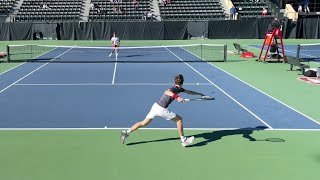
[146,103,177,120]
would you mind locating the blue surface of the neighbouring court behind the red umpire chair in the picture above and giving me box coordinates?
[249,44,320,63]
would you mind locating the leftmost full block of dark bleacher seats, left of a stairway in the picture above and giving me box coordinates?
[16,0,84,21]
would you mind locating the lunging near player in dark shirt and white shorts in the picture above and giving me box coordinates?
[120,74,204,147]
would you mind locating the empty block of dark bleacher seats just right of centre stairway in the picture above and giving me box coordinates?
[159,0,226,20]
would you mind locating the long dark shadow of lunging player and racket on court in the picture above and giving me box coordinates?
[127,126,285,147]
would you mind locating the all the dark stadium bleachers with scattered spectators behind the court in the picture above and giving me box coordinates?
[0,0,282,22]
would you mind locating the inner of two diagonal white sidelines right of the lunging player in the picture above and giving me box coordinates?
[166,48,273,129]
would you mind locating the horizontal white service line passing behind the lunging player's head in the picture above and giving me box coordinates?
[14,83,212,86]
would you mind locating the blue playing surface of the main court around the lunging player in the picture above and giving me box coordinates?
[0,48,320,129]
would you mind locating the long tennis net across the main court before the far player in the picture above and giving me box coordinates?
[7,44,227,63]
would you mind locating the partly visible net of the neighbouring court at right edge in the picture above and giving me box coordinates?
[296,43,320,61]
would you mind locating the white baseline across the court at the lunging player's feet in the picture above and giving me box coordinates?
[0,127,320,132]
